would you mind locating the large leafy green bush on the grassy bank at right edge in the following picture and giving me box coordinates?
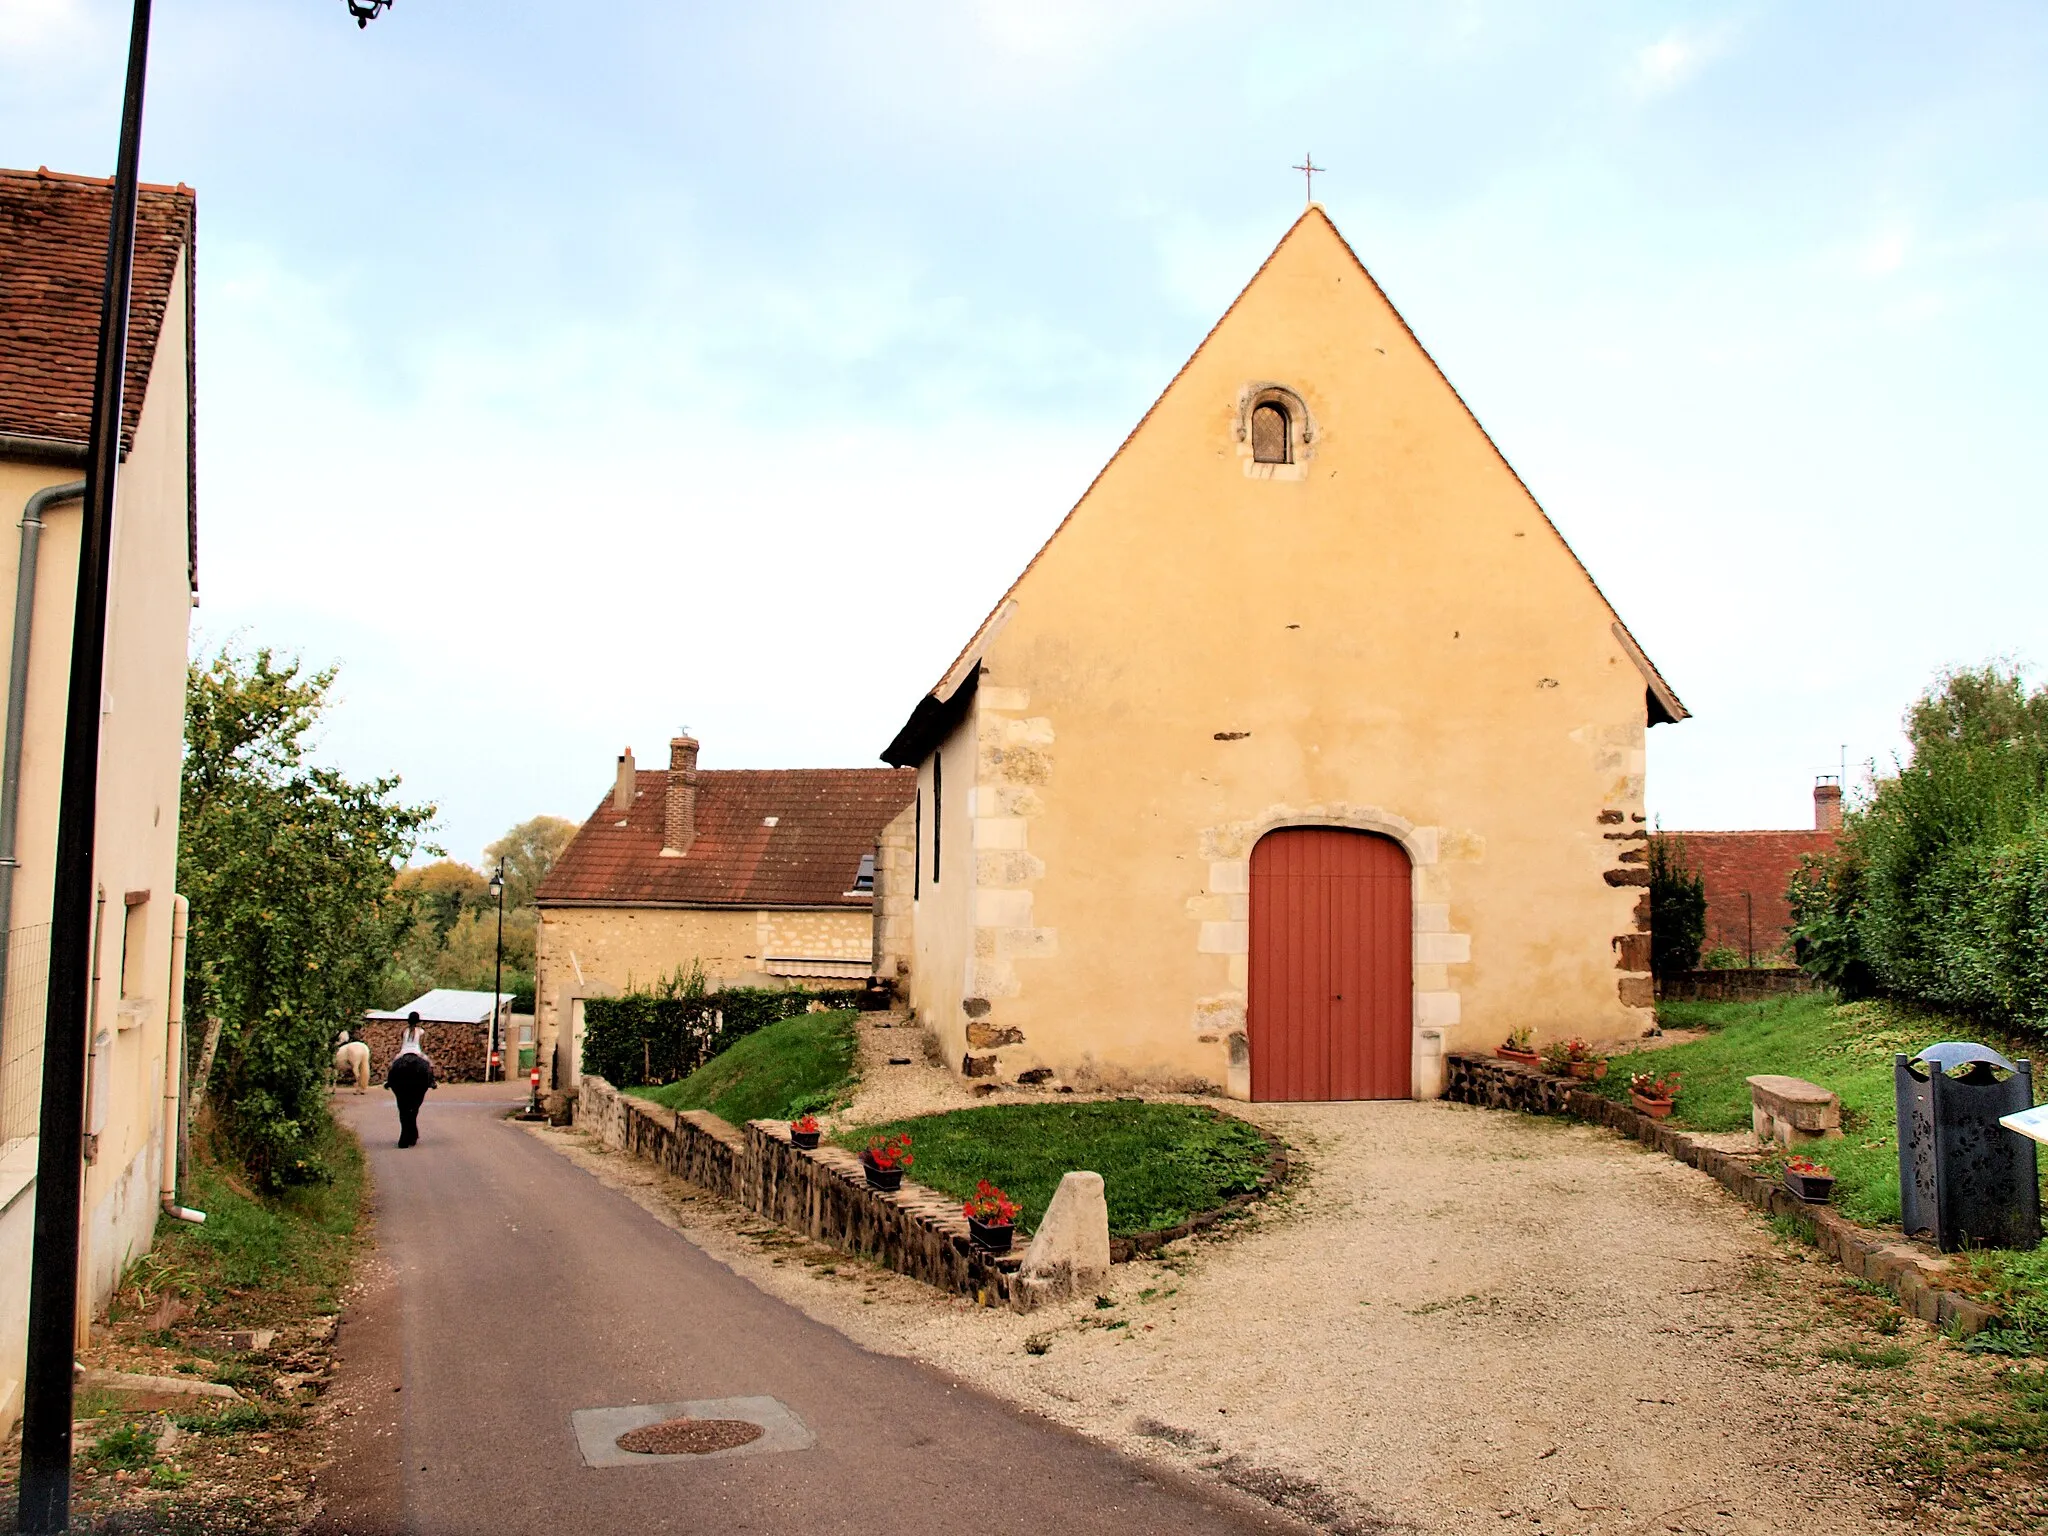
[1788,668,2048,1028]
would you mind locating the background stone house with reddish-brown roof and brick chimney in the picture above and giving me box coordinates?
[535,735,915,1087]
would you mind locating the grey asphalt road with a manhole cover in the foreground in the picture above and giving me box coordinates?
[311,1085,1305,1536]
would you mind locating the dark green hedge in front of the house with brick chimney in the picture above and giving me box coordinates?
[584,985,864,1087]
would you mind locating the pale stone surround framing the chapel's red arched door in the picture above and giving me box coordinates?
[1190,803,1473,1100]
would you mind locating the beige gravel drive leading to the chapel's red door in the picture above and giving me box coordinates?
[537,1030,2048,1536]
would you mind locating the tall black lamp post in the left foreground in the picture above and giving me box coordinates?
[16,0,150,1536]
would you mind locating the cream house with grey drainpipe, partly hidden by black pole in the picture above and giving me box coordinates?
[0,170,199,1434]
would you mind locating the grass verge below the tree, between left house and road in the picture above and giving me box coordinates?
[117,1124,369,1323]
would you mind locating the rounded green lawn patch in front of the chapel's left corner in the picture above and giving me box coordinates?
[838,1102,1270,1237]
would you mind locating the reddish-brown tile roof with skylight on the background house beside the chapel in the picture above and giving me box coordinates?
[537,768,918,907]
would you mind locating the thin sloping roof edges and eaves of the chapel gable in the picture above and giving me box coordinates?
[881,203,1692,764]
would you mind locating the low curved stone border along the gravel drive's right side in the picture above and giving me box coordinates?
[1444,1051,2003,1337]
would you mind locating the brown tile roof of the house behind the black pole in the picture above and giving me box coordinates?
[0,168,199,586]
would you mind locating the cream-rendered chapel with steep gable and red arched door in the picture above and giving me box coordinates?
[883,205,1686,1100]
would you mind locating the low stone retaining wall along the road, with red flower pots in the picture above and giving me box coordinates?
[575,1075,1022,1305]
